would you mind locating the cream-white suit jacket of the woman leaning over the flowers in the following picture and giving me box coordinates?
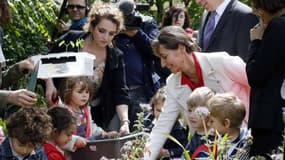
[147,52,247,160]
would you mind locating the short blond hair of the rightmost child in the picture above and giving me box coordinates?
[208,93,246,128]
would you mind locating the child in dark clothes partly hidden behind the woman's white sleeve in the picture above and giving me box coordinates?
[143,87,187,160]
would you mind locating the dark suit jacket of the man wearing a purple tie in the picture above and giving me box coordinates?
[198,0,258,61]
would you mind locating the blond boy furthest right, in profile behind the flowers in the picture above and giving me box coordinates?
[208,93,251,160]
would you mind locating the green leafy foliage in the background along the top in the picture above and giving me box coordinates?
[3,0,250,65]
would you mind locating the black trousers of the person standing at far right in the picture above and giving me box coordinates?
[250,129,283,160]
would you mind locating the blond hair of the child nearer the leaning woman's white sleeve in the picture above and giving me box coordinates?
[186,87,215,109]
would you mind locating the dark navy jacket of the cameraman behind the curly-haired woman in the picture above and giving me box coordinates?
[114,15,162,95]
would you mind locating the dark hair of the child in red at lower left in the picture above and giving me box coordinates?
[48,106,76,133]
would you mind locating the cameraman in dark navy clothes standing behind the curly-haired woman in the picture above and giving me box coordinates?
[114,0,159,130]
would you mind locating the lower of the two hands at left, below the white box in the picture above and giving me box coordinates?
[7,89,37,107]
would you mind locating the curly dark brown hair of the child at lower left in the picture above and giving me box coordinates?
[7,107,52,145]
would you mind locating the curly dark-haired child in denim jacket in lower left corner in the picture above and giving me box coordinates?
[0,107,52,160]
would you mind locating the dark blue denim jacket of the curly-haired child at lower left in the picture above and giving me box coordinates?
[0,138,47,160]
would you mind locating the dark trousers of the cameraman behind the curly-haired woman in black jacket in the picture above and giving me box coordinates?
[129,86,152,132]
